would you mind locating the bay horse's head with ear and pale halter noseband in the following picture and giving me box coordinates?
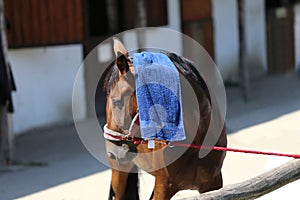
[104,38,137,161]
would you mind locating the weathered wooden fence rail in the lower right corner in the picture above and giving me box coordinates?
[182,159,300,200]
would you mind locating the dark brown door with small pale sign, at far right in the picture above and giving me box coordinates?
[266,0,295,74]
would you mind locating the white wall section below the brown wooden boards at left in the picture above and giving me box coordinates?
[9,45,85,134]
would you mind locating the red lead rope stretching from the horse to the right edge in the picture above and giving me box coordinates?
[171,142,300,159]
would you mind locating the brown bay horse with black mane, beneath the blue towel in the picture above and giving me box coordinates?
[103,38,227,200]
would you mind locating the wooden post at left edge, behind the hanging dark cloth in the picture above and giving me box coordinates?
[0,0,14,165]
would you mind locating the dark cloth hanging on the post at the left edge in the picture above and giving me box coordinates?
[0,34,16,113]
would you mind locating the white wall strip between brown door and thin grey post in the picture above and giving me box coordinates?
[212,0,239,81]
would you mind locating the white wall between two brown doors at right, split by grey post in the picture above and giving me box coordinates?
[212,0,267,81]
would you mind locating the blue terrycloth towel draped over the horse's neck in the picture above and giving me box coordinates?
[133,52,186,141]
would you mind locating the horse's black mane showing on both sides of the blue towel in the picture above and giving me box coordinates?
[102,52,211,101]
